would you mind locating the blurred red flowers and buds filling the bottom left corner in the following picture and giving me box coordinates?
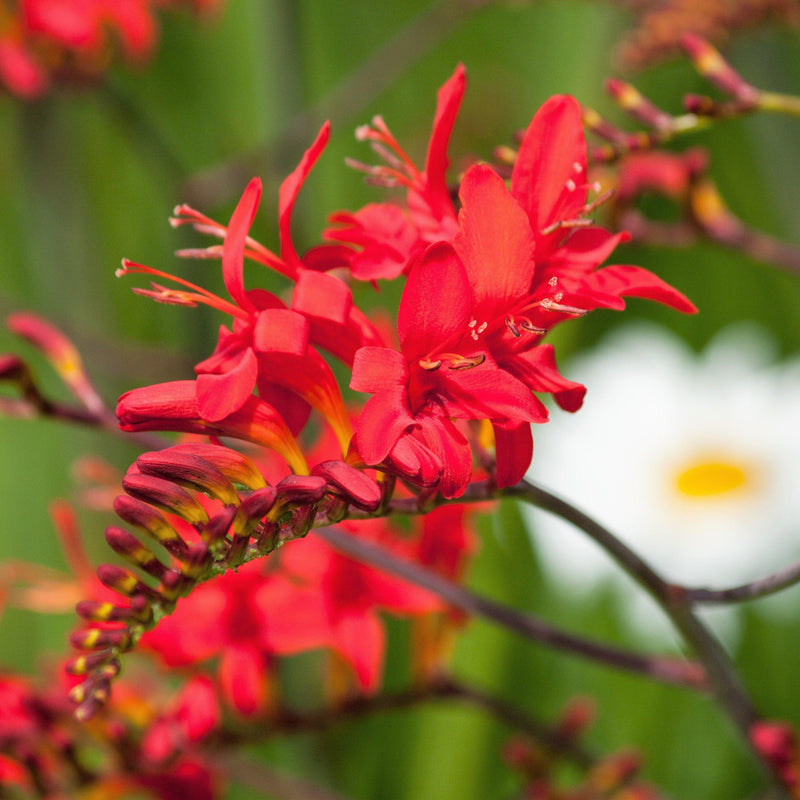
[0,674,221,800]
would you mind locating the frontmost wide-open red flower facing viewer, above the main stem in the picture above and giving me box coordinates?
[350,238,547,497]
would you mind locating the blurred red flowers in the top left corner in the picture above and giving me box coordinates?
[0,0,220,99]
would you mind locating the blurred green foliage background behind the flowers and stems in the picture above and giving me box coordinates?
[0,0,800,800]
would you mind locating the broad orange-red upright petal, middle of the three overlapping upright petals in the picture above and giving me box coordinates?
[454,164,534,322]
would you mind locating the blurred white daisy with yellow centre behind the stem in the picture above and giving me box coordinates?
[526,324,800,640]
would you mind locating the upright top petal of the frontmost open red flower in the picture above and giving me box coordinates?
[397,242,472,362]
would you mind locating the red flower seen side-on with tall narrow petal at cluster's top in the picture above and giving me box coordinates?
[325,64,466,281]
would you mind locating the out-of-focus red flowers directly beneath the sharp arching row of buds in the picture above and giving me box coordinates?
[142,520,446,700]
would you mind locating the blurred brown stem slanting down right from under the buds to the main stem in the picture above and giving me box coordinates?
[314,528,706,689]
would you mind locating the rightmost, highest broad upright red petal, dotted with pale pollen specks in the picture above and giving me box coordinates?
[511,95,586,247]
